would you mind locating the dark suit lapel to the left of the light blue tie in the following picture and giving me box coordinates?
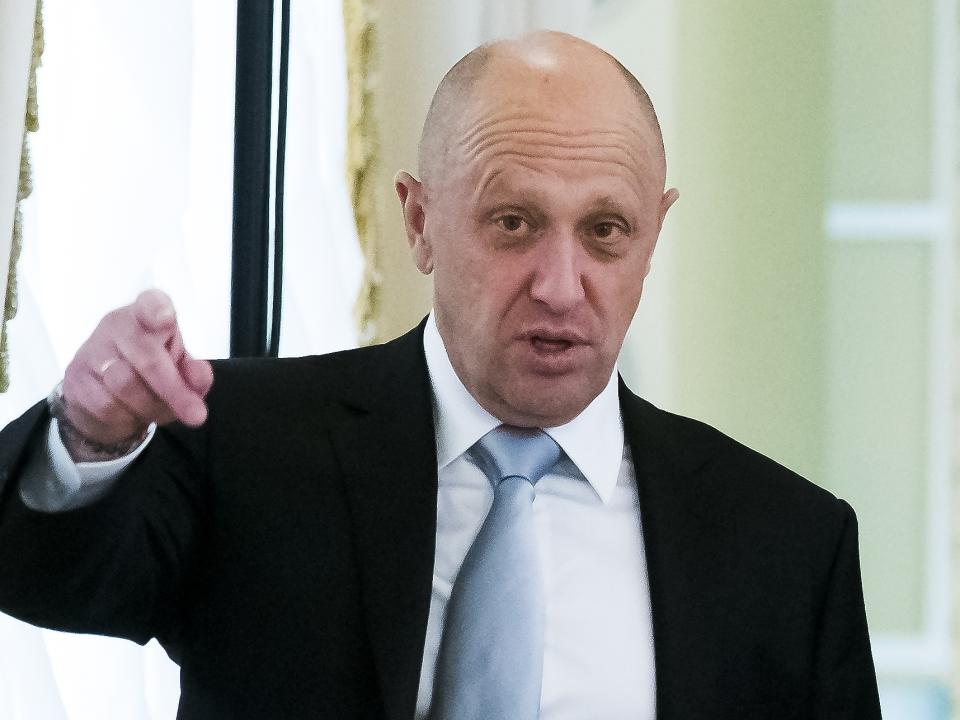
[328,324,437,720]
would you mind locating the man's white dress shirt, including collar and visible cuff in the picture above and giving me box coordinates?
[20,314,656,720]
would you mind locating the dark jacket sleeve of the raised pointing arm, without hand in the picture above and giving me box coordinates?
[0,403,205,644]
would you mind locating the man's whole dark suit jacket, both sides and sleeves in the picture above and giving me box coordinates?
[0,325,880,720]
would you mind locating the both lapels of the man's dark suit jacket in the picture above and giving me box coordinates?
[328,338,732,720]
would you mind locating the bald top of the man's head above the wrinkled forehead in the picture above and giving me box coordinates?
[418,31,666,188]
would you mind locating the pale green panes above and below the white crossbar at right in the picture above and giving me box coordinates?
[825,0,934,633]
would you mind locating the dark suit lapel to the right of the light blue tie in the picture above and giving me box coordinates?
[620,381,730,720]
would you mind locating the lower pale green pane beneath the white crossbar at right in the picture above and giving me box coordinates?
[825,240,930,632]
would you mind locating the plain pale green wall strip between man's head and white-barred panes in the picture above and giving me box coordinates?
[673,0,830,479]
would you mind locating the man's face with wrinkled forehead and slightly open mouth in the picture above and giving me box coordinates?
[401,56,673,427]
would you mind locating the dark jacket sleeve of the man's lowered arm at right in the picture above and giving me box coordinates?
[812,500,880,720]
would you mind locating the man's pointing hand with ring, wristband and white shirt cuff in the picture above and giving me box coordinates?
[10,290,213,512]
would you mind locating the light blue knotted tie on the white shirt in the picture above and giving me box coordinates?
[430,425,561,720]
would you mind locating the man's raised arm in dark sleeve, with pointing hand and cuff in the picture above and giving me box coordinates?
[0,291,213,642]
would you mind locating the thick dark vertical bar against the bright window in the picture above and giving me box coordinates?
[230,0,273,357]
